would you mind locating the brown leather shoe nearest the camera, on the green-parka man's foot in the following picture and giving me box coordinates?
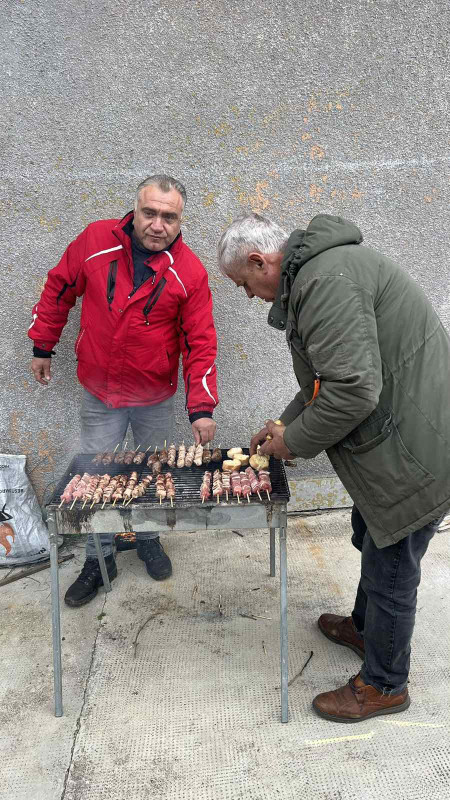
[313,674,411,722]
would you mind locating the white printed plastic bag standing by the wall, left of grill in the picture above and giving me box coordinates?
[0,453,50,567]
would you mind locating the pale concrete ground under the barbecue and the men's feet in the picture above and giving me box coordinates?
[0,511,450,800]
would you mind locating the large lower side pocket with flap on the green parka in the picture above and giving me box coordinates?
[341,415,435,508]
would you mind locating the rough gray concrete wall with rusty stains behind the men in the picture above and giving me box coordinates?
[0,0,450,500]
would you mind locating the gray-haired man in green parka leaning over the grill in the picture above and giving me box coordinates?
[218,214,450,722]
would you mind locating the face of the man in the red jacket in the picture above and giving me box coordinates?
[133,185,183,251]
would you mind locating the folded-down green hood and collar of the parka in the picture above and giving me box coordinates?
[268,214,363,330]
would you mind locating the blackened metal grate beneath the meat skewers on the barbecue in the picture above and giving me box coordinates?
[49,448,290,511]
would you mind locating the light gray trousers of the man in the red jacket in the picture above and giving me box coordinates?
[81,389,174,559]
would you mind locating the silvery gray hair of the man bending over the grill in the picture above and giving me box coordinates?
[217,213,288,276]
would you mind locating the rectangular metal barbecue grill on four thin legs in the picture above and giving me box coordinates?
[47,450,290,722]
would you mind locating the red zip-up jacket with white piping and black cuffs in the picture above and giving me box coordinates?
[28,213,218,414]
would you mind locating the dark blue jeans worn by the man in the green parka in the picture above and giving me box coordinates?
[352,506,443,695]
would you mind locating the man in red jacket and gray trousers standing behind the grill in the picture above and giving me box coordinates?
[28,175,218,607]
